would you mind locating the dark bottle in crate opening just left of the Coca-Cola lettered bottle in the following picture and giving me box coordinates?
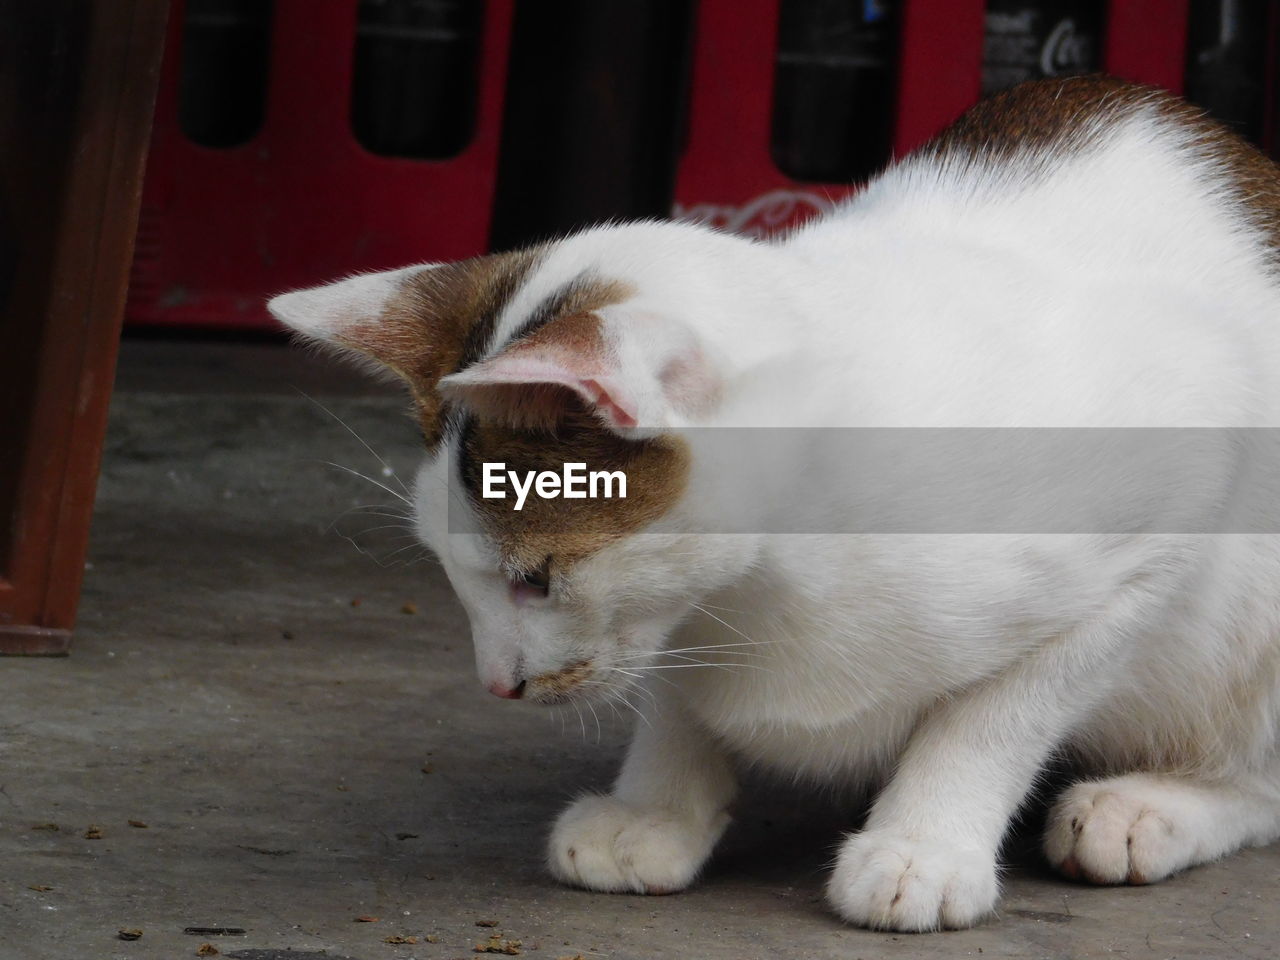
[772,0,899,183]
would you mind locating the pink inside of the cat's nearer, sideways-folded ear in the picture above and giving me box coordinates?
[442,351,637,426]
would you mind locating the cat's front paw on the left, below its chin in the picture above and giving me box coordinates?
[549,796,728,893]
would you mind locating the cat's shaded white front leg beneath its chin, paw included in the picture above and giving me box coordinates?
[549,698,736,893]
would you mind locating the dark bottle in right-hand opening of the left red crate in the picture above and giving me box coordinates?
[351,0,484,160]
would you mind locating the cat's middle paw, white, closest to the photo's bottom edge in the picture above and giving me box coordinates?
[827,829,1000,932]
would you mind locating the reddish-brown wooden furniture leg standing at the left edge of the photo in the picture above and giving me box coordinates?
[0,0,168,655]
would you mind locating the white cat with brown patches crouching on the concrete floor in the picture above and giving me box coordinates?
[270,77,1280,931]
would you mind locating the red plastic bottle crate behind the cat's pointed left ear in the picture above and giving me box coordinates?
[127,0,513,329]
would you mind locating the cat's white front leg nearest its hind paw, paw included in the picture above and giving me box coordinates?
[827,637,1107,931]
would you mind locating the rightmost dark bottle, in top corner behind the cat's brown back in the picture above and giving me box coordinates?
[1187,0,1272,145]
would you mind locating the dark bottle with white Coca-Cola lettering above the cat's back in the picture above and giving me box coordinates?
[982,0,1105,96]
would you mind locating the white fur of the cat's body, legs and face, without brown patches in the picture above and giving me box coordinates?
[275,97,1280,931]
